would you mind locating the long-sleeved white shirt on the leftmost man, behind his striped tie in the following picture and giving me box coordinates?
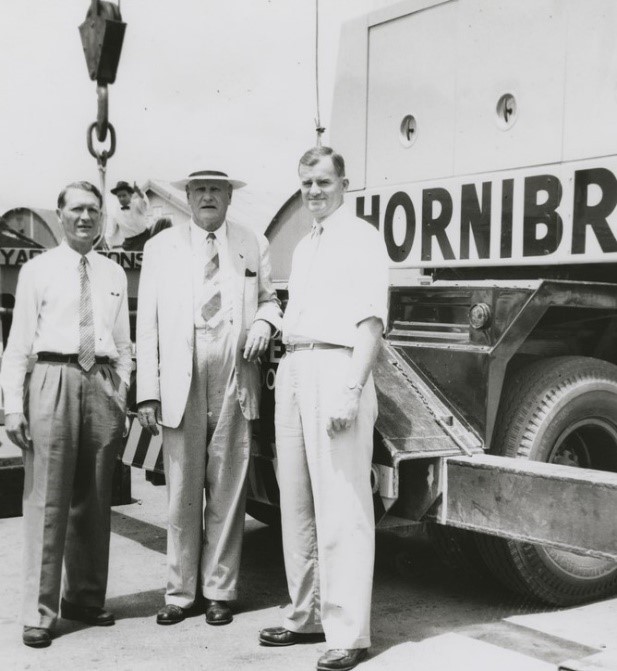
[0,242,132,414]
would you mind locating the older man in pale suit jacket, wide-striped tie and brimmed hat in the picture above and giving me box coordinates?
[137,170,282,624]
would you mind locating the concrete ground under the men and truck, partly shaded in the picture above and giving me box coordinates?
[0,471,617,671]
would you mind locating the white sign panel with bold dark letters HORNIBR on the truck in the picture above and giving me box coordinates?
[354,156,617,268]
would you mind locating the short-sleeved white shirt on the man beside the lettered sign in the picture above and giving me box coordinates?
[283,206,388,347]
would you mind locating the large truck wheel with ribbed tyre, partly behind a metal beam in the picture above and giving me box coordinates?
[477,356,617,606]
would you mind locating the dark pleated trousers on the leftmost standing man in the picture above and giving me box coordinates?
[23,362,125,628]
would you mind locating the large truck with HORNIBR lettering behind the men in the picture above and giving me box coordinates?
[248,0,617,606]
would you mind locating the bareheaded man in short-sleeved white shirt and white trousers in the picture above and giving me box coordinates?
[259,147,388,671]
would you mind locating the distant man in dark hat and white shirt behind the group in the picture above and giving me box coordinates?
[105,181,150,252]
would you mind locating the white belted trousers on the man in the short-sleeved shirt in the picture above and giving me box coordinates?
[275,349,377,648]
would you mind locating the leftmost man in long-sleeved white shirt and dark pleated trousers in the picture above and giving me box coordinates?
[0,182,131,647]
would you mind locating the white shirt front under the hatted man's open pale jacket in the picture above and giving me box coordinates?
[189,219,233,328]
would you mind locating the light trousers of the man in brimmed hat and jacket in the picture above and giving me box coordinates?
[163,328,250,608]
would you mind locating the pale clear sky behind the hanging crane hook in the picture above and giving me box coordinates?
[0,0,391,211]
